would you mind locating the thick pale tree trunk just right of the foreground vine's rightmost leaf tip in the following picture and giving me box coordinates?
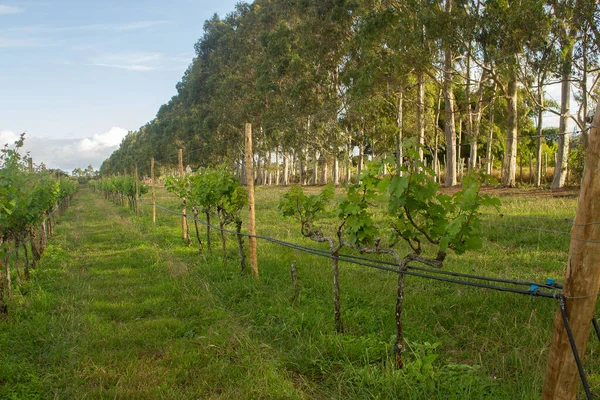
[502,76,518,187]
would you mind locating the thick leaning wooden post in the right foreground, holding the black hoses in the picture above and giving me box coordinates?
[542,103,600,400]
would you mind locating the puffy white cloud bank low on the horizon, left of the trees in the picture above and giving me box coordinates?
[0,127,127,172]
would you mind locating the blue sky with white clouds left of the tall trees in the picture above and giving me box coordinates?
[0,0,238,171]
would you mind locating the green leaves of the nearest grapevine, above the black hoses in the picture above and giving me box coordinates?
[279,140,500,261]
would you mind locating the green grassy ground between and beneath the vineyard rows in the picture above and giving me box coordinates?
[0,188,600,399]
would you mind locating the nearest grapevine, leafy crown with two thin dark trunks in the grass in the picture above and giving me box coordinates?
[279,140,500,368]
